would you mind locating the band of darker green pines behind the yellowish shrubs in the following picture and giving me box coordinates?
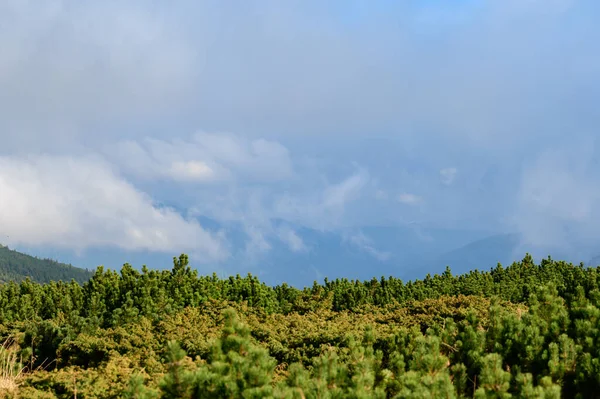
[0,255,600,327]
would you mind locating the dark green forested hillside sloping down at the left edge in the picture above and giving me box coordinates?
[0,245,92,283]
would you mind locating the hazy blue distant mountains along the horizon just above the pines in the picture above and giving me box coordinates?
[10,220,600,287]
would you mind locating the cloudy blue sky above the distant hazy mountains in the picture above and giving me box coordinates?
[0,0,600,282]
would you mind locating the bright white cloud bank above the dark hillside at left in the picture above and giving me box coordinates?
[0,156,227,261]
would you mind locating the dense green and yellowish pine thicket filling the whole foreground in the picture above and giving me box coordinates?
[0,255,600,399]
